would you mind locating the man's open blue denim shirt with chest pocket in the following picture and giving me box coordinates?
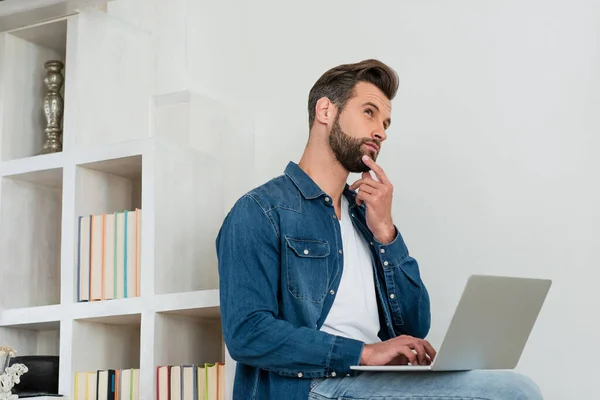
[216,162,430,400]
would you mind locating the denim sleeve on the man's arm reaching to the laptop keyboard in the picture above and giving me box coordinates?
[216,195,364,378]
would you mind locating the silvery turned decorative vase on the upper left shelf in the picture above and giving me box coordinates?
[40,60,64,154]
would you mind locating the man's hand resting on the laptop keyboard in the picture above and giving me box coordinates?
[360,335,436,365]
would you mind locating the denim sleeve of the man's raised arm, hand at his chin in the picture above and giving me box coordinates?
[373,227,431,339]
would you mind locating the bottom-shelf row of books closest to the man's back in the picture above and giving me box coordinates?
[156,362,225,400]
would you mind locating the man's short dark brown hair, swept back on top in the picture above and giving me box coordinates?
[308,59,398,129]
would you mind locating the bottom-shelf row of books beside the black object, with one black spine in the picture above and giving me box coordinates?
[74,368,140,400]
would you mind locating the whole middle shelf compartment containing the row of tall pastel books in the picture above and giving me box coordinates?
[74,154,142,301]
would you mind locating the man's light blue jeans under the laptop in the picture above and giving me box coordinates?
[309,370,543,400]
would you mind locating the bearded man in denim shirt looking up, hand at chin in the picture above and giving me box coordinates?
[216,60,541,400]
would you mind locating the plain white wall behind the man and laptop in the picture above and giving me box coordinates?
[109,0,600,400]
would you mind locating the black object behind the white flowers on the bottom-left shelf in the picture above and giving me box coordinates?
[9,356,59,397]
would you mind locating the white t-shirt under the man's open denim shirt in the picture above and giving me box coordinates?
[321,196,381,344]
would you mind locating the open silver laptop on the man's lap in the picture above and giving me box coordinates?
[350,275,552,371]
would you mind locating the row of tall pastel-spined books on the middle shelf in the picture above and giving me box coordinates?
[77,208,142,301]
